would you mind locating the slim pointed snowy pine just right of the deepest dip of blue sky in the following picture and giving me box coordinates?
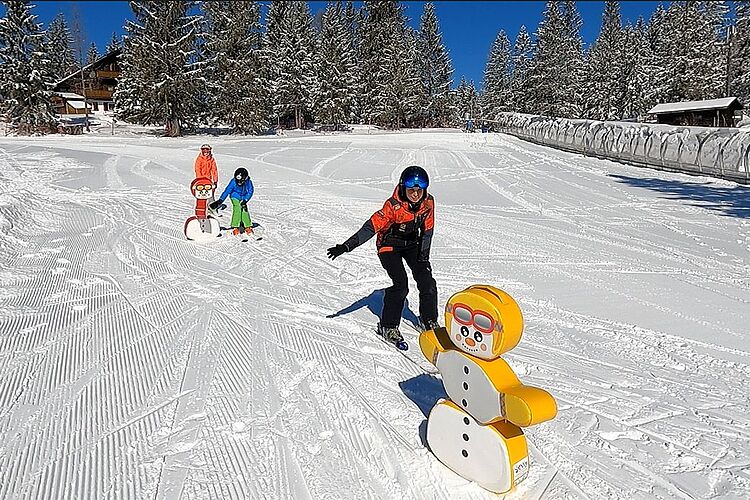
[480,30,511,120]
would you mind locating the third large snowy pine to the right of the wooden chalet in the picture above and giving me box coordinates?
[267,0,318,128]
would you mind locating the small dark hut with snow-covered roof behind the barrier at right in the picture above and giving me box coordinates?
[648,97,743,127]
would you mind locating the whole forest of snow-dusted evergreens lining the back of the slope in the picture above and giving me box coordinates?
[0,0,750,135]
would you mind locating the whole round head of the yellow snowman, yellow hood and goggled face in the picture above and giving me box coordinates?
[445,285,523,360]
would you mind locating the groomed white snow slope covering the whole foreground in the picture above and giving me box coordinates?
[0,128,750,499]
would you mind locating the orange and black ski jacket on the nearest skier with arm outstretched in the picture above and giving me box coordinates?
[344,186,435,261]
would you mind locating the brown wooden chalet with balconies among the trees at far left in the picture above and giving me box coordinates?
[52,49,122,114]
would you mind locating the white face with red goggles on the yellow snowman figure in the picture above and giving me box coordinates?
[449,302,503,359]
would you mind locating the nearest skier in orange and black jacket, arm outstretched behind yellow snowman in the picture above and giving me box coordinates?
[327,165,439,348]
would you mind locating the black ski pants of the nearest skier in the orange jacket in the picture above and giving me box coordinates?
[378,245,437,328]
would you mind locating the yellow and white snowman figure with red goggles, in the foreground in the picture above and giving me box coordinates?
[419,285,557,493]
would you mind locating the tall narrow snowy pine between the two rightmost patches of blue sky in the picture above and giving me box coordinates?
[583,0,628,120]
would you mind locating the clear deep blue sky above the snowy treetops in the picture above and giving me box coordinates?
[27,1,667,86]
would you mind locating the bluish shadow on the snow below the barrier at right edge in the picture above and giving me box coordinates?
[609,174,750,218]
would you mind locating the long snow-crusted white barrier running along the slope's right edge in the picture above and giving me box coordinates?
[493,113,750,184]
